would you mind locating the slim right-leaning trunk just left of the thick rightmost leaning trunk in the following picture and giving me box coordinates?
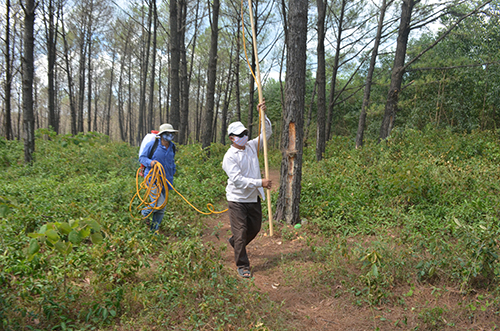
[356,0,392,148]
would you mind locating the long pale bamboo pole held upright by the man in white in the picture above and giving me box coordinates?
[248,0,273,237]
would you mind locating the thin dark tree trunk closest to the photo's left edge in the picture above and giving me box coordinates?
[4,0,14,140]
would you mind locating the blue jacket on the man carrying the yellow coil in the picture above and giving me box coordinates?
[139,138,176,190]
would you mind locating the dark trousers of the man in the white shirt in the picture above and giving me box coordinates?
[228,197,262,268]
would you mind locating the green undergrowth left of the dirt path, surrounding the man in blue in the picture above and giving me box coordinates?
[0,130,280,330]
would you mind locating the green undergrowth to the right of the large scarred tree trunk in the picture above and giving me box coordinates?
[301,129,500,328]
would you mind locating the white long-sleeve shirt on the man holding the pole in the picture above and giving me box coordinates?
[222,116,273,202]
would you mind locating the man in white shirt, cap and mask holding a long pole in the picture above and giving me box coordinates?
[222,102,272,278]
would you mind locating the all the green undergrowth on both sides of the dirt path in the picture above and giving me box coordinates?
[0,129,500,330]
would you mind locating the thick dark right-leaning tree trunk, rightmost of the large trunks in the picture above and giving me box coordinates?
[379,0,420,140]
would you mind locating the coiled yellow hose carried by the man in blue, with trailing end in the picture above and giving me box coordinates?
[129,162,227,219]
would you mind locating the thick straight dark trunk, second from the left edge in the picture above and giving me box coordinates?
[22,0,36,164]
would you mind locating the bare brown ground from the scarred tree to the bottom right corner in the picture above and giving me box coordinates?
[200,169,500,331]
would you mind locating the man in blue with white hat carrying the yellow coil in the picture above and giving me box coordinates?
[139,123,178,232]
